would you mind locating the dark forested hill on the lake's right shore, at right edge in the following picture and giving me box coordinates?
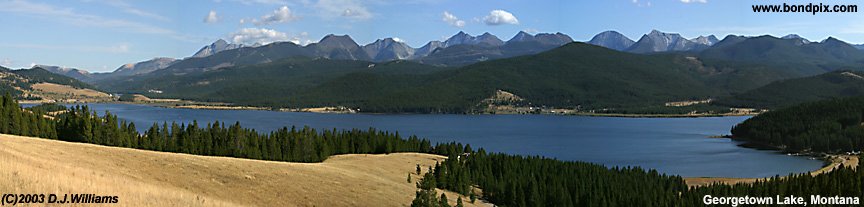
[732,97,864,153]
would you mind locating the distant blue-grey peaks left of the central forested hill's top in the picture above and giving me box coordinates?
[33,32,573,82]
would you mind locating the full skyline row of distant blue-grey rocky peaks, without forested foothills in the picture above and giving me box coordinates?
[32,30,864,85]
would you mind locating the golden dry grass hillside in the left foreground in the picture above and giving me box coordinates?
[0,135,488,206]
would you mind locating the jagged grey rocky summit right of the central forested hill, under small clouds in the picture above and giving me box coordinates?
[627,30,708,53]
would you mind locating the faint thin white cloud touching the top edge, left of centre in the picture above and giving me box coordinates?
[314,0,372,20]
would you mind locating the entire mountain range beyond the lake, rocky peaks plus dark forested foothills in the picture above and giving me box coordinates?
[20,30,864,113]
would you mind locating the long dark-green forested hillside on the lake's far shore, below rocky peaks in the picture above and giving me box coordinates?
[99,43,789,113]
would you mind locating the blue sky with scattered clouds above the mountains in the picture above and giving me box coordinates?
[0,0,864,72]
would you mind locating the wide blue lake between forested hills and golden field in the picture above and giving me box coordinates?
[55,104,822,177]
